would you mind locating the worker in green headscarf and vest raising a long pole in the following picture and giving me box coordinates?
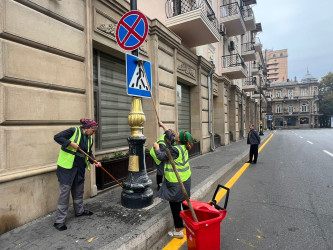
[154,122,194,238]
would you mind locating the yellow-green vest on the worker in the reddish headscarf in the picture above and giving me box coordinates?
[57,127,92,170]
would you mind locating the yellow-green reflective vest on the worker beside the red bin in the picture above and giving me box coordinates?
[164,145,191,182]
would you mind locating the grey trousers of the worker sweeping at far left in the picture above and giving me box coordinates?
[55,176,84,223]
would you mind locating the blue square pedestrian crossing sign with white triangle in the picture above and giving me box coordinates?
[126,54,151,98]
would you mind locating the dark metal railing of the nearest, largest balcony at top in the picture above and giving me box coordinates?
[165,0,218,28]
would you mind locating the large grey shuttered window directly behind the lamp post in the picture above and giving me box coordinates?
[93,51,132,150]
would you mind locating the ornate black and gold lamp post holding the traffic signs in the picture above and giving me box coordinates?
[121,0,153,209]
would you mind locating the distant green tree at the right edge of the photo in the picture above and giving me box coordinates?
[319,72,333,115]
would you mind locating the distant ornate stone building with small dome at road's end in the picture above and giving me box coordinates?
[266,72,320,129]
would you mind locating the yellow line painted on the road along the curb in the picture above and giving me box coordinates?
[163,134,274,250]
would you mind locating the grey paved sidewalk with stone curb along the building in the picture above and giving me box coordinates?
[0,131,271,250]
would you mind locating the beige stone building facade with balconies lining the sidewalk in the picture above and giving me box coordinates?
[0,0,265,233]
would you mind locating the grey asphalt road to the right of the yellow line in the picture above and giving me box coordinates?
[221,129,333,250]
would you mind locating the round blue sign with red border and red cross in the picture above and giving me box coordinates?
[116,10,149,50]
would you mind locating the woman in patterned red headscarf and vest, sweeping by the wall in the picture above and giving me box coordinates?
[54,118,101,231]
